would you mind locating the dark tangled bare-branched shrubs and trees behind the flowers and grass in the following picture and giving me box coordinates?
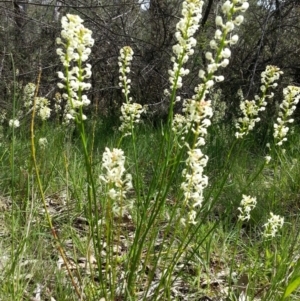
[0,0,300,119]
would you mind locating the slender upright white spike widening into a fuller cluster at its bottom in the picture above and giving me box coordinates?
[118,46,145,136]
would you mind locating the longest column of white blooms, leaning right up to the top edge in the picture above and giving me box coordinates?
[177,0,248,224]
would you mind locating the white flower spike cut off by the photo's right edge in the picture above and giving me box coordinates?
[273,86,300,145]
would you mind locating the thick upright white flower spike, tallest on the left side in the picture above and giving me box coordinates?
[56,14,94,122]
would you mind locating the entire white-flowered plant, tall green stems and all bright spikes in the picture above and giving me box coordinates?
[26,0,299,300]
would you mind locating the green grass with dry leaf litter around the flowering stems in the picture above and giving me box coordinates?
[0,120,300,300]
